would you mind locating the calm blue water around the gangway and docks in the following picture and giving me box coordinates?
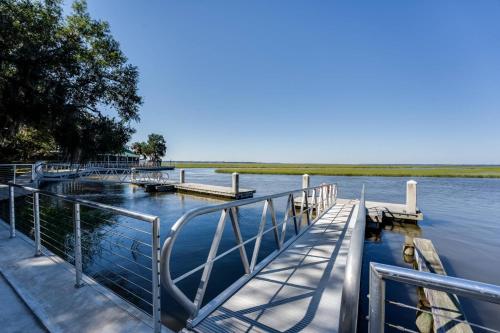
[38,169,500,331]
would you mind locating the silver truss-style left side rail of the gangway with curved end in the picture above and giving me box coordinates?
[160,184,337,326]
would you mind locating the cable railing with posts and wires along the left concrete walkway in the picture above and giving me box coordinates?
[0,183,161,332]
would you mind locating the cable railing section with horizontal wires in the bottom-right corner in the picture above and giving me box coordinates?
[368,262,500,333]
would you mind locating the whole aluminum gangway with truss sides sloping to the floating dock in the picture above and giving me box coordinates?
[161,184,366,332]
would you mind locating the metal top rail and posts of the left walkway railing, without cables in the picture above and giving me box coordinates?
[0,182,161,332]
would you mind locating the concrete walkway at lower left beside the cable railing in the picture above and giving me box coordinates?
[0,220,162,333]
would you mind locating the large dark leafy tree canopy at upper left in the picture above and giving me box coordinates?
[0,0,142,161]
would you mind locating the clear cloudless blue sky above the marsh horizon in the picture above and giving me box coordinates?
[64,0,500,164]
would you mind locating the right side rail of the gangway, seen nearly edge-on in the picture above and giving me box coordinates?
[339,185,366,333]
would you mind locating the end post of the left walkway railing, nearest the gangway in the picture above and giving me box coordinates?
[151,218,161,333]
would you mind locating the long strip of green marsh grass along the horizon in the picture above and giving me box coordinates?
[170,162,500,178]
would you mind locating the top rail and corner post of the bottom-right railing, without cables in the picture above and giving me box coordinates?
[368,262,500,333]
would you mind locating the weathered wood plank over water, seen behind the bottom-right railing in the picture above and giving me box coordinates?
[413,238,472,333]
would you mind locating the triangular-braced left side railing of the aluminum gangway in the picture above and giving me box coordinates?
[161,184,337,327]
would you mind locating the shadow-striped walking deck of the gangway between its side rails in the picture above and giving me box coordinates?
[193,201,358,332]
